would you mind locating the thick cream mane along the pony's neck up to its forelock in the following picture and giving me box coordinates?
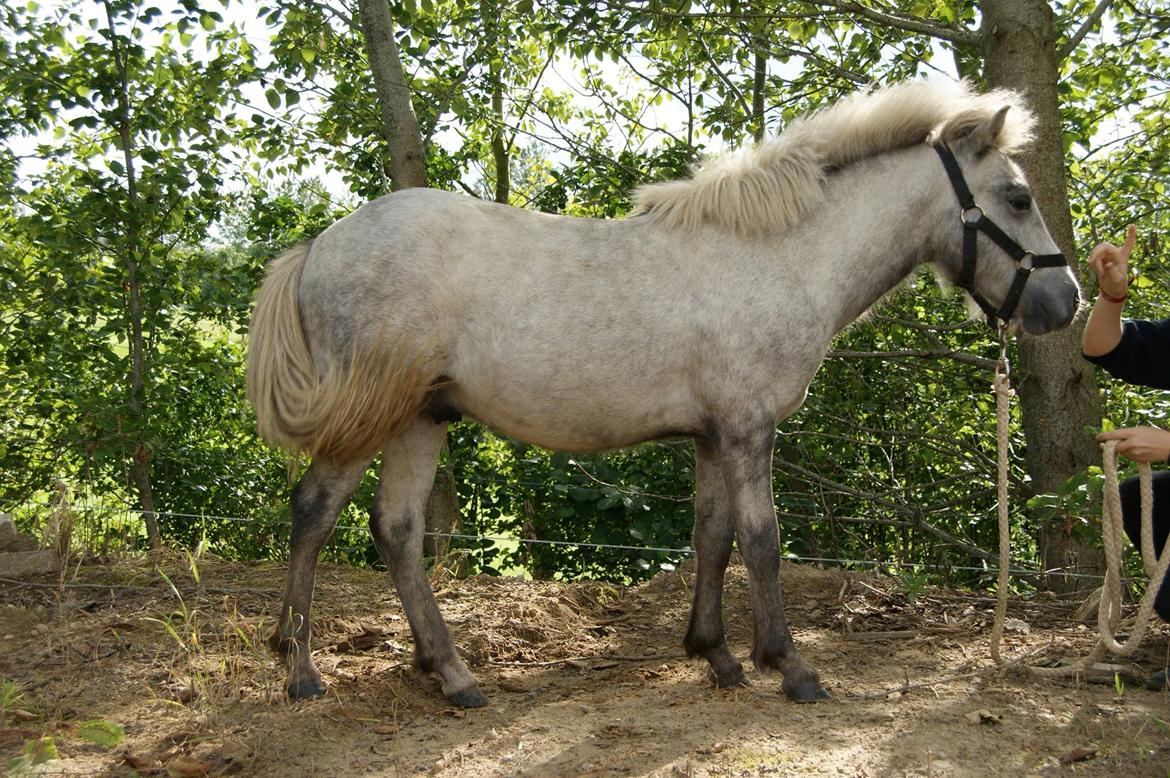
[634,82,1034,234]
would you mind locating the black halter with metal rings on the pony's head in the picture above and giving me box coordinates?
[934,142,1068,329]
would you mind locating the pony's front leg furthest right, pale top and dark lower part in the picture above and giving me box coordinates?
[717,424,830,702]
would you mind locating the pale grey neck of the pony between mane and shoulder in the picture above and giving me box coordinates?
[800,146,958,333]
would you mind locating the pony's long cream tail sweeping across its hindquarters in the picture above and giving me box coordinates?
[247,242,434,462]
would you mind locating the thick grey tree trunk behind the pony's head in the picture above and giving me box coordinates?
[982,0,1102,591]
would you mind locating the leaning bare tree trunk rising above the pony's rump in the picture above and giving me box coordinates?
[358,0,427,190]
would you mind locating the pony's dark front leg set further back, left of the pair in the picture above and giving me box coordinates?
[682,439,748,689]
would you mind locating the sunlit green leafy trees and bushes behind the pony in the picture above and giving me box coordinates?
[0,0,1170,585]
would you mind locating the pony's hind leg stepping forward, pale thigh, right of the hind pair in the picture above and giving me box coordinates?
[370,418,488,708]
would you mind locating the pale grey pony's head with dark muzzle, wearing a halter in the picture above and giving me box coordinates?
[934,106,1080,335]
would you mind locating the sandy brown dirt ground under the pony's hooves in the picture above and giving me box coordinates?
[0,559,1170,778]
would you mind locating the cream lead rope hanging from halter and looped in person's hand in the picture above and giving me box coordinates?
[991,343,1170,676]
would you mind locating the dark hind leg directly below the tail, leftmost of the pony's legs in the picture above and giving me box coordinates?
[268,460,369,700]
